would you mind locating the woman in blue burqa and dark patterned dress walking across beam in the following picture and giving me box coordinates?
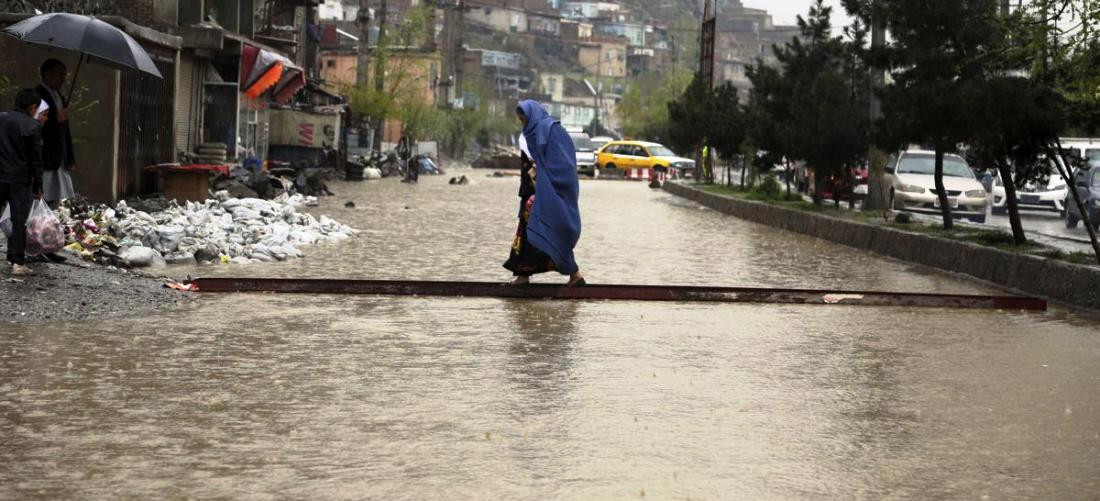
[504,100,584,286]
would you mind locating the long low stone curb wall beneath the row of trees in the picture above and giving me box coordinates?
[663,183,1100,311]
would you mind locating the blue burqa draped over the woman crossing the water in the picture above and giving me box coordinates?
[517,100,581,275]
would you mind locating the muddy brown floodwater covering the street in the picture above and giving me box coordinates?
[0,172,1100,500]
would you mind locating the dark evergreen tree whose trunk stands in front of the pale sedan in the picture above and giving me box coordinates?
[879,0,1002,229]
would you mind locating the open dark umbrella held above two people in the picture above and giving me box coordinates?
[3,13,164,99]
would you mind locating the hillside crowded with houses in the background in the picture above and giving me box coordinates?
[320,0,796,148]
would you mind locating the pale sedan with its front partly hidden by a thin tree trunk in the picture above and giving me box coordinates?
[886,150,989,222]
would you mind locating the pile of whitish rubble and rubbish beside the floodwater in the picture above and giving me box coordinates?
[59,192,356,268]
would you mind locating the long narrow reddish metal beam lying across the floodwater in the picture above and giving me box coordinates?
[189,277,1046,312]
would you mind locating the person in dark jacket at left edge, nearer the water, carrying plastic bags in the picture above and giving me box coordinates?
[0,89,42,275]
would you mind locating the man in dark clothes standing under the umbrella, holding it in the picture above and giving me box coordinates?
[36,58,76,208]
